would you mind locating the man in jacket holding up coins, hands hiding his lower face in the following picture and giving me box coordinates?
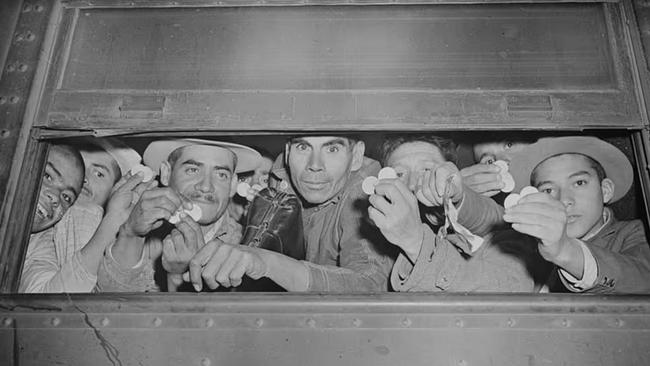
[368,134,544,292]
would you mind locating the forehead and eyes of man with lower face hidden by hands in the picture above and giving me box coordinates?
[386,141,447,193]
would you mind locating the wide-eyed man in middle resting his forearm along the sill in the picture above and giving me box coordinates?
[182,136,394,293]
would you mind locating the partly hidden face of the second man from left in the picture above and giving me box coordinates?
[79,150,121,207]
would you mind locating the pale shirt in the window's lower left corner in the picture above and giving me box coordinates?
[19,202,104,293]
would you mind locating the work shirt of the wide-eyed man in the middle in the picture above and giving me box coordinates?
[274,157,397,293]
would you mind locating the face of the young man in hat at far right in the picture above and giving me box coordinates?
[533,154,614,239]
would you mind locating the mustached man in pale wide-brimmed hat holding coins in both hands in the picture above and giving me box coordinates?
[98,139,260,291]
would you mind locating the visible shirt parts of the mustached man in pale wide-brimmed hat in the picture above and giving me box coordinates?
[97,211,242,292]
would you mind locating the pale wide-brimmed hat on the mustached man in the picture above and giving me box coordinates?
[144,139,262,173]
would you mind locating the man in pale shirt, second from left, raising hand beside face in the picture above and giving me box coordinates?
[20,139,144,293]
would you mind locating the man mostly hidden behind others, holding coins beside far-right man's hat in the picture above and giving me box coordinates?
[460,134,537,197]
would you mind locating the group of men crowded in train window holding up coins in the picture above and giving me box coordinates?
[20,134,650,293]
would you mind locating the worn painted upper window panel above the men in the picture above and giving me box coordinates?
[38,2,642,132]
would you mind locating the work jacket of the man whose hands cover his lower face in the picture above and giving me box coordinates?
[391,187,550,292]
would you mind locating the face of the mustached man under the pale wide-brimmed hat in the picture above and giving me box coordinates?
[161,145,237,225]
